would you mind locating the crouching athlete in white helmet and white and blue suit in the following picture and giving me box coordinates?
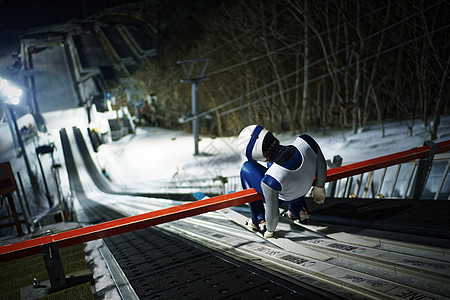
[238,125,327,238]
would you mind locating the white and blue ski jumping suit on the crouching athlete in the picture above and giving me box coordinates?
[241,134,327,231]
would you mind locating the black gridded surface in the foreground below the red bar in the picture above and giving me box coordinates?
[104,228,310,299]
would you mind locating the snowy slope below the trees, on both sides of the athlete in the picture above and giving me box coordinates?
[96,116,450,187]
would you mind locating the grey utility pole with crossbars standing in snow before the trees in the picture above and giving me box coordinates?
[177,58,211,155]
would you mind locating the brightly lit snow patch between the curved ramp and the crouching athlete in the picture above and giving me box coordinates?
[97,127,242,185]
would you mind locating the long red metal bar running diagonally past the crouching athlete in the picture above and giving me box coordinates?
[0,141,450,261]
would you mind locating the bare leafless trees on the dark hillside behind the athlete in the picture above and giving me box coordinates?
[121,0,450,139]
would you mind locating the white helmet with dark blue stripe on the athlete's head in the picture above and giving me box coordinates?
[238,125,269,161]
